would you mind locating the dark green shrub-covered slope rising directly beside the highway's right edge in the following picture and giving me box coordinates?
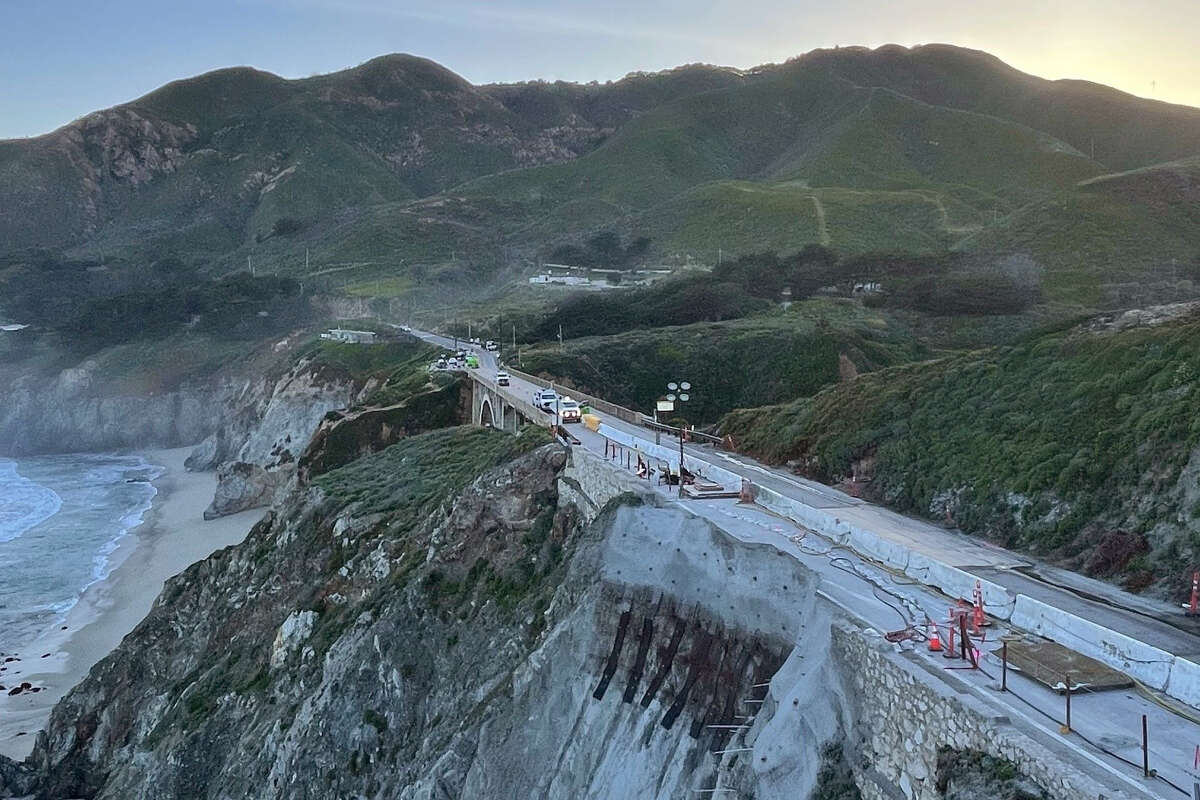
[720,311,1200,594]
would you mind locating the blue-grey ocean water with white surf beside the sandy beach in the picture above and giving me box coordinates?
[0,453,163,652]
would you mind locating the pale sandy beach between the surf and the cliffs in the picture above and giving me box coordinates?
[0,447,263,760]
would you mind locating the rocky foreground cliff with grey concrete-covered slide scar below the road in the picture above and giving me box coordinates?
[0,428,845,800]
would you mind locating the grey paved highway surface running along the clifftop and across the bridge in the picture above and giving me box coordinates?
[412,323,1200,798]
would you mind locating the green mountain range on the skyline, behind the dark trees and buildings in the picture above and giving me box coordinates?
[0,39,1200,328]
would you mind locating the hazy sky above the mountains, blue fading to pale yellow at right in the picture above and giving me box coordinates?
[0,0,1200,138]
